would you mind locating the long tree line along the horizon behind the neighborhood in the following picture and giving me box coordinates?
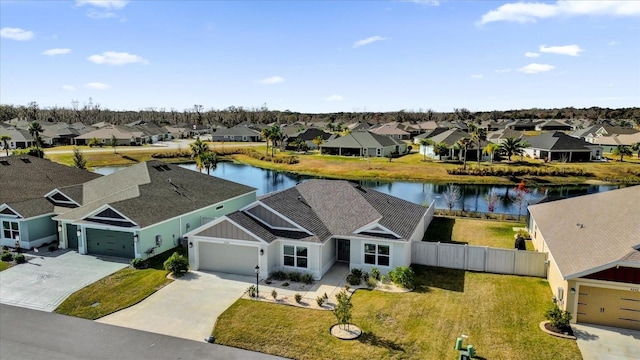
[0,98,640,127]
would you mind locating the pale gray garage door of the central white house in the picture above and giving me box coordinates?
[198,242,258,275]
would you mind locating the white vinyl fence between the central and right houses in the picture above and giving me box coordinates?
[411,241,547,278]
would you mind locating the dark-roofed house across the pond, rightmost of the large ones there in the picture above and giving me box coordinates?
[523,131,602,162]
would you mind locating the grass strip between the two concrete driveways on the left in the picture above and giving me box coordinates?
[56,249,185,320]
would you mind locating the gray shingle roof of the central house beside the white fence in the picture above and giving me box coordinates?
[229,180,426,242]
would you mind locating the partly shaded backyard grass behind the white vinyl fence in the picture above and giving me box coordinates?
[423,216,535,250]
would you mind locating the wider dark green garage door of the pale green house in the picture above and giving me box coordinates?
[86,229,135,259]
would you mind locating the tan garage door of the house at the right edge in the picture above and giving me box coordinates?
[577,286,640,330]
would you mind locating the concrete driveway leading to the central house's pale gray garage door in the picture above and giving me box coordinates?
[96,271,255,341]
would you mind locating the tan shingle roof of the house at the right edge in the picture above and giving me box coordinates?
[529,186,640,279]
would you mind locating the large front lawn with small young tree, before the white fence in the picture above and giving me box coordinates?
[213,266,580,360]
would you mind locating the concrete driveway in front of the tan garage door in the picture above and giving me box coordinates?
[571,324,640,360]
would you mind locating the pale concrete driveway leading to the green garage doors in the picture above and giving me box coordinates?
[0,250,128,312]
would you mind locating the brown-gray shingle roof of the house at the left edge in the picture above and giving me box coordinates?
[0,156,101,217]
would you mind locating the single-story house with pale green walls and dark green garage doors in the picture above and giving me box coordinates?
[48,161,256,259]
